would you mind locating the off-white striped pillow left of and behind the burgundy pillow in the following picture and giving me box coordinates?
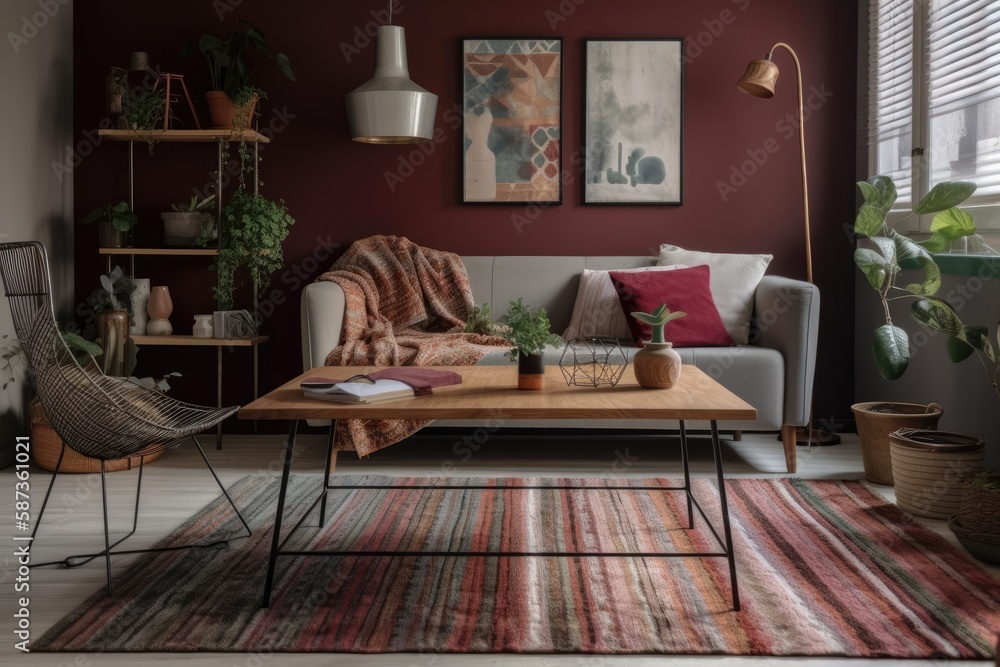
[563,265,684,340]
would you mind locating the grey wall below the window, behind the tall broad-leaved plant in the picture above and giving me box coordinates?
[854,270,1000,469]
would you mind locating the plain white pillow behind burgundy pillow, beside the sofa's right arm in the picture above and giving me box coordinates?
[658,243,774,345]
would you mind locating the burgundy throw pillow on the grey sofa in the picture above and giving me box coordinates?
[608,265,733,347]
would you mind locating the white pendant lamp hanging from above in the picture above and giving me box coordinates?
[345,2,437,144]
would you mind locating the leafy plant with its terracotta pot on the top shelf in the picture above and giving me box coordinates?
[189,20,295,129]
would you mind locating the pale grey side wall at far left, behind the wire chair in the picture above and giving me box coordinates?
[0,0,73,467]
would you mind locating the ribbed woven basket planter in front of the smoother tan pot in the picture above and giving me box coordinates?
[889,428,986,519]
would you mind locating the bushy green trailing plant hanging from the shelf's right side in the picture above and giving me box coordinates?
[205,188,295,310]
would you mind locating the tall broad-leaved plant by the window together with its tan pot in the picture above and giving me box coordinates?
[851,176,976,484]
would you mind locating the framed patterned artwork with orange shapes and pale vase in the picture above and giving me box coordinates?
[462,38,562,204]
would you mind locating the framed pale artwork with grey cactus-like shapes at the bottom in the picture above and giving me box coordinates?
[583,39,684,205]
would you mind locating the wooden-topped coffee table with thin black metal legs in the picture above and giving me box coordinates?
[239,366,757,611]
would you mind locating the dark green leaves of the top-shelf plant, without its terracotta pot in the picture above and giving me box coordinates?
[185,20,295,99]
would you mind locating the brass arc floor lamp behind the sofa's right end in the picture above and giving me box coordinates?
[736,42,840,445]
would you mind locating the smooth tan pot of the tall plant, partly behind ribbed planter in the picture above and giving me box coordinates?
[851,401,944,486]
